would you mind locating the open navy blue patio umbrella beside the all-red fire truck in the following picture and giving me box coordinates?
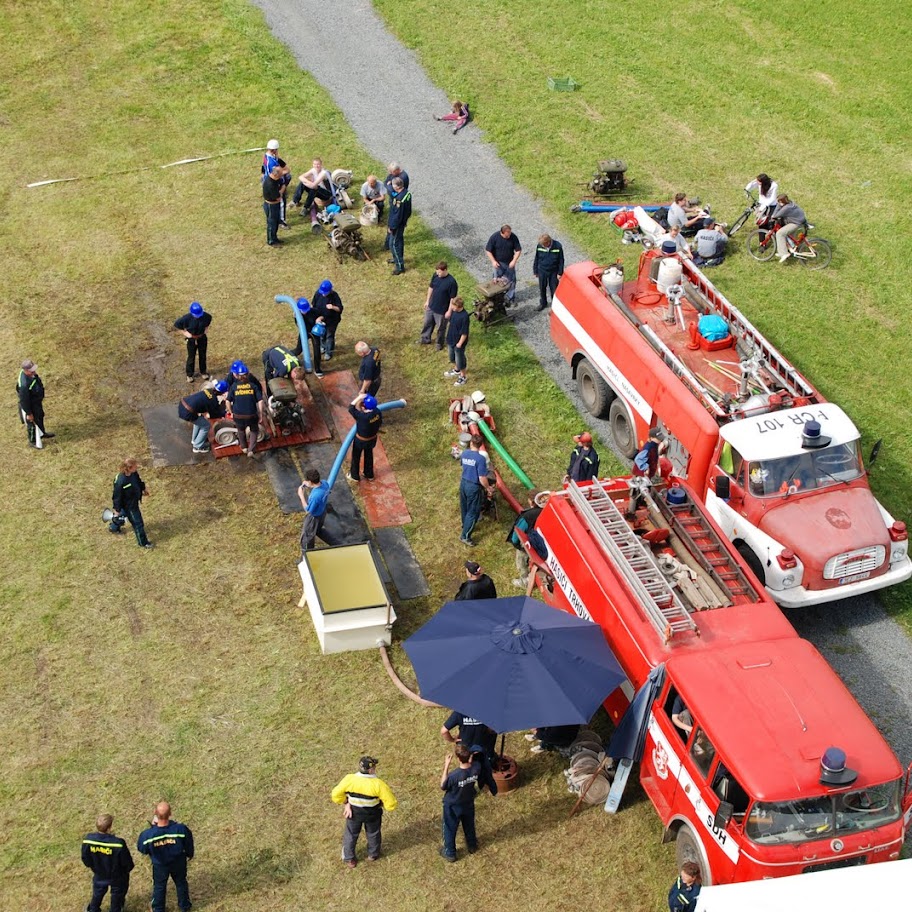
[404,596,625,732]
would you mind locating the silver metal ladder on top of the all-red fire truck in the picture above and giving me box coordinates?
[567,481,700,643]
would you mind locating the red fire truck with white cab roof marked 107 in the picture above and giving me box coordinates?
[551,250,912,607]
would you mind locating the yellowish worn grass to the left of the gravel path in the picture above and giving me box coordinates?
[0,0,674,912]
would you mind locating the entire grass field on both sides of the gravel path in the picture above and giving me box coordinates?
[0,0,912,912]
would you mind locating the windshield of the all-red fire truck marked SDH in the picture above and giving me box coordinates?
[746,780,900,845]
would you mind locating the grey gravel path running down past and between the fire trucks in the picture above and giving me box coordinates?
[254,0,912,784]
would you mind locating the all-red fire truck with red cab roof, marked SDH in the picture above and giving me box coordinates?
[527,479,912,883]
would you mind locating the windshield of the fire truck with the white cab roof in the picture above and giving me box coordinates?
[748,440,864,497]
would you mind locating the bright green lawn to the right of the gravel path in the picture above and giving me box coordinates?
[375,0,912,626]
